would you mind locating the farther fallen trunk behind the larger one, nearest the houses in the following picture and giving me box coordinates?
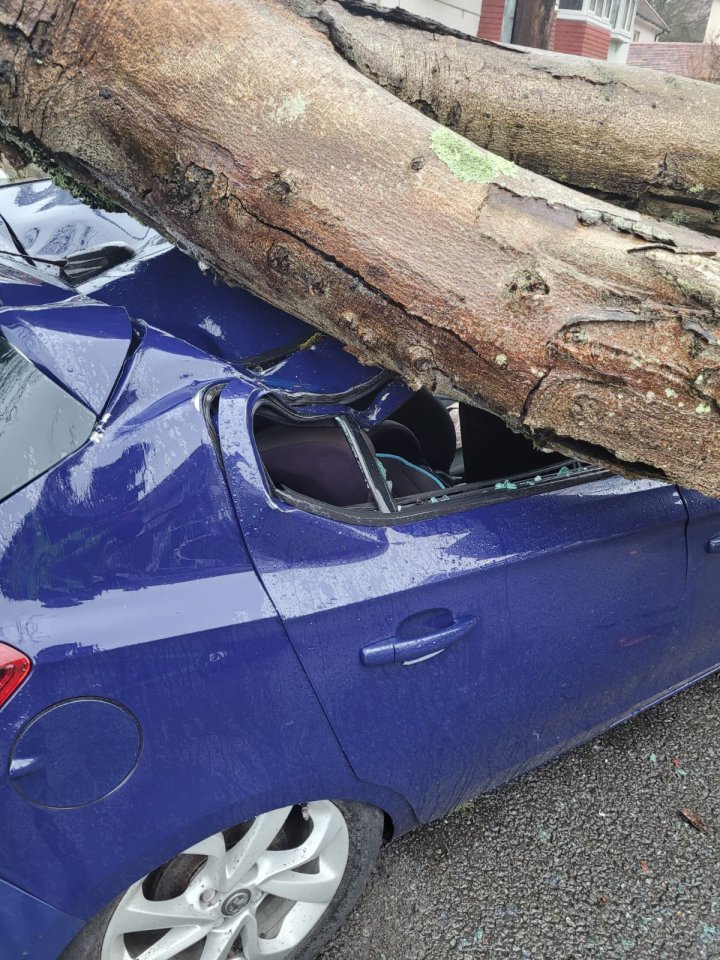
[304,0,720,234]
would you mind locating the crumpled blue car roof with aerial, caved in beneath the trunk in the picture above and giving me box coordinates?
[0,180,391,399]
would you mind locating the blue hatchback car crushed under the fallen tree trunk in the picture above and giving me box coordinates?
[0,181,720,960]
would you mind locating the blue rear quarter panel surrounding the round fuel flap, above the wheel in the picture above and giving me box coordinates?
[0,310,416,944]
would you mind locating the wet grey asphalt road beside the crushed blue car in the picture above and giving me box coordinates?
[323,676,720,960]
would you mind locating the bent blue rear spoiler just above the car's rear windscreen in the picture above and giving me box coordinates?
[0,297,132,414]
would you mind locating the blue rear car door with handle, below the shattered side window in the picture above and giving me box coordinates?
[219,385,686,818]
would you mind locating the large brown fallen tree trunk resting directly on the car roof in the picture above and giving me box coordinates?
[0,0,720,495]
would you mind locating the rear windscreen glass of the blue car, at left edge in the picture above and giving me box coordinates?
[0,337,95,500]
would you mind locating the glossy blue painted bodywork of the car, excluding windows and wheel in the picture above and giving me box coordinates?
[0,185,720,960]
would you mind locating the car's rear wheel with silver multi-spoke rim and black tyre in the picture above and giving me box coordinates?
[59,800,385,960]
